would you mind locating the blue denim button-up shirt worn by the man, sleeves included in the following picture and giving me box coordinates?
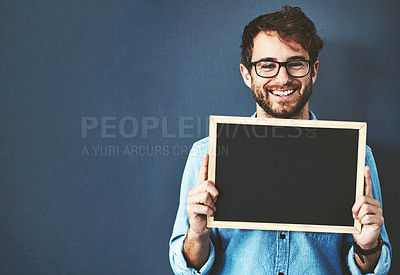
[169,113,392,275]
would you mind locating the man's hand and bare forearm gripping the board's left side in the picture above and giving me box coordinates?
[183,154,218,270]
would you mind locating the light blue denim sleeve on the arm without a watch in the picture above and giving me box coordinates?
[169,139,215,275]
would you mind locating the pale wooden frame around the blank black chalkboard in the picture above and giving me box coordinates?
[207,116,367,233]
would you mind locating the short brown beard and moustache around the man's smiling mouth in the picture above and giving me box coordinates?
[251,77,313,118]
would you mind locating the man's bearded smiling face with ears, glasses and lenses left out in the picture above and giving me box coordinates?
[241,32,318,118]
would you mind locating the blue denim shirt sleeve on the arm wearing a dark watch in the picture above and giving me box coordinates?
[346,146,392,275]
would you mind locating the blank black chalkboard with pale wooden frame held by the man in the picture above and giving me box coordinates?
[208,116,367,233]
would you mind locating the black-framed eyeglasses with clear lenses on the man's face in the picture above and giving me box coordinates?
[250,60,311,78]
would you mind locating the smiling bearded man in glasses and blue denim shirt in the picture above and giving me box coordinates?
[170,7,391,274]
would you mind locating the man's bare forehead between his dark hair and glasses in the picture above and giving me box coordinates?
[252,32,309,62]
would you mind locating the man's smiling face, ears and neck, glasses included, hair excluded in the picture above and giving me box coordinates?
[240,31,322,119]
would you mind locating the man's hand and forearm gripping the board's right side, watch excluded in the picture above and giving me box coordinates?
[352,166,383,272]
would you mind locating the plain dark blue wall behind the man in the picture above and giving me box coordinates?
[0,0,400,274]
